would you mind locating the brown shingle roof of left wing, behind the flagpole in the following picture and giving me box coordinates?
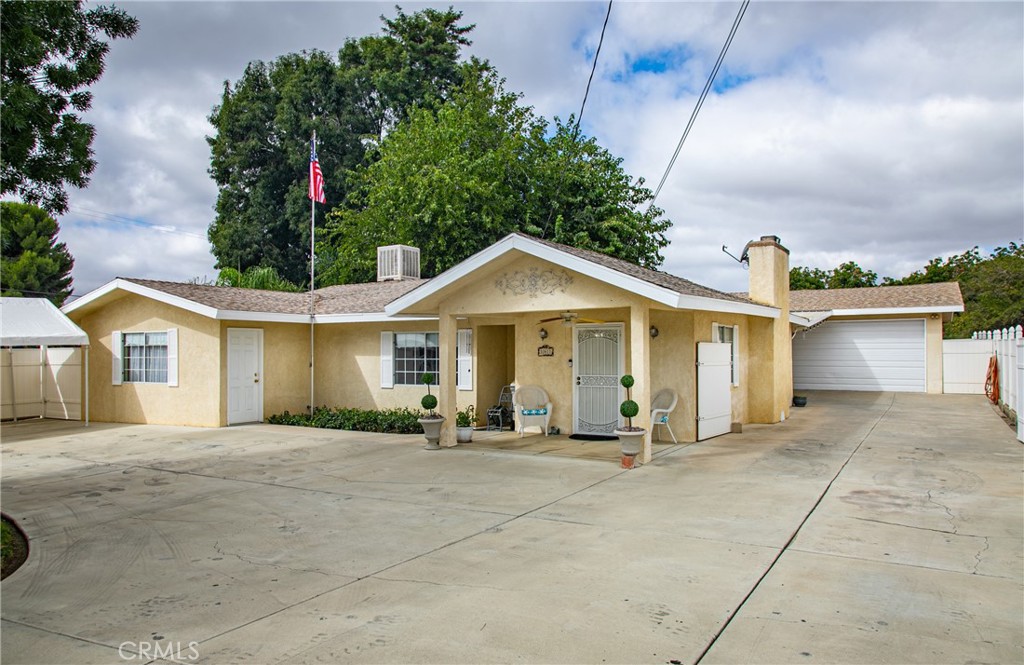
[120,278,426,315]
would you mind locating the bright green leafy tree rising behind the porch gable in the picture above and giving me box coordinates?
[317,70,671,283]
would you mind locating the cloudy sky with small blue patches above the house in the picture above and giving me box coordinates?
[59,0,1024,294]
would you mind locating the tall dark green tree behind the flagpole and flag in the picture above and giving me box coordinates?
[207,9,472,284]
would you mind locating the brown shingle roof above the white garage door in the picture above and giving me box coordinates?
[790,282,964,311]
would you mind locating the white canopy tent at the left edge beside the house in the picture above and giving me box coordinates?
[0,297,89,425]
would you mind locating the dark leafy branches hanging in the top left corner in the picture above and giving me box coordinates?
[0,0,138,214]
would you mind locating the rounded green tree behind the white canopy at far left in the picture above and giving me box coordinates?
[0,201,75,307]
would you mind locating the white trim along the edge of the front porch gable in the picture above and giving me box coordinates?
[384,234,779,319]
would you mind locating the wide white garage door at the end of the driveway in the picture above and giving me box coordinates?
[793,319,927,392]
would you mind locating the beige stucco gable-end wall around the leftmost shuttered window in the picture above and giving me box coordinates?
[69,294,222,427]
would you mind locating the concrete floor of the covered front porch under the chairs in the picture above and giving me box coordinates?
[459,429,690,466]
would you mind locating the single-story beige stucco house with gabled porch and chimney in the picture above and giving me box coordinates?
[65,234,963,458]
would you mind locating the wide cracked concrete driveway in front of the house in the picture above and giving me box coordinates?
[0,392,1024,665]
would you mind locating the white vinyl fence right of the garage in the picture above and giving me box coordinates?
[942,326,1024,441]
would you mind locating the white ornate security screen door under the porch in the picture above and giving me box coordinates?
[572,324,625,435]
